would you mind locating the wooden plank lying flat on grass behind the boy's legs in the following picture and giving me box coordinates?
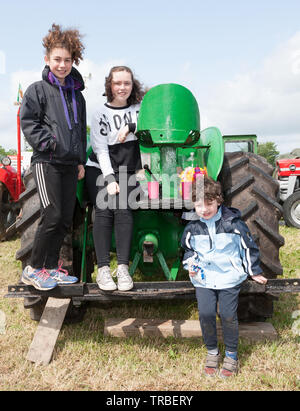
[104,318,277,341]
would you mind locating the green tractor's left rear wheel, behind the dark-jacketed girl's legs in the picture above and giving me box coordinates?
[16,169,89,321]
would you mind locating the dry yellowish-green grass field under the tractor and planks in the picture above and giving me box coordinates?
[0,227,300,391]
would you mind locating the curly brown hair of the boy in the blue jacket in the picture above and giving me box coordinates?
[192,175,223,204]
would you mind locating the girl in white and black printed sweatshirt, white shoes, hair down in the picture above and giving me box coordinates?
[86,66,144,291]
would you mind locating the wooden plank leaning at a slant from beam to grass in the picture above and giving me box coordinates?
[26,297,71,365]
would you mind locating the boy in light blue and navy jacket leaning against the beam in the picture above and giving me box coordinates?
[181,175,267,378]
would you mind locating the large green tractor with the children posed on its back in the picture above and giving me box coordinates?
[11,84,284,320]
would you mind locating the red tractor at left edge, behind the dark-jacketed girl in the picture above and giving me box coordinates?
[0,108,25,241]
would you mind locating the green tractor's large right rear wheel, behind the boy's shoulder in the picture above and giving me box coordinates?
[219,152,284,321]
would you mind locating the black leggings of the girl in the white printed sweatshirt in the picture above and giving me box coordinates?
[85,166,134,268]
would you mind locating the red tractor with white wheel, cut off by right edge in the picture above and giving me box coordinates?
[276,149,300,228]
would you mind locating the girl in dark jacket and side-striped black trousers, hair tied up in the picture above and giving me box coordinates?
[20,24,86,290]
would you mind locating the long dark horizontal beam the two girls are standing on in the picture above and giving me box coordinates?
[5,278,300,301]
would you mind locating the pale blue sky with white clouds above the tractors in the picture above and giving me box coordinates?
[0,0,300,153]
